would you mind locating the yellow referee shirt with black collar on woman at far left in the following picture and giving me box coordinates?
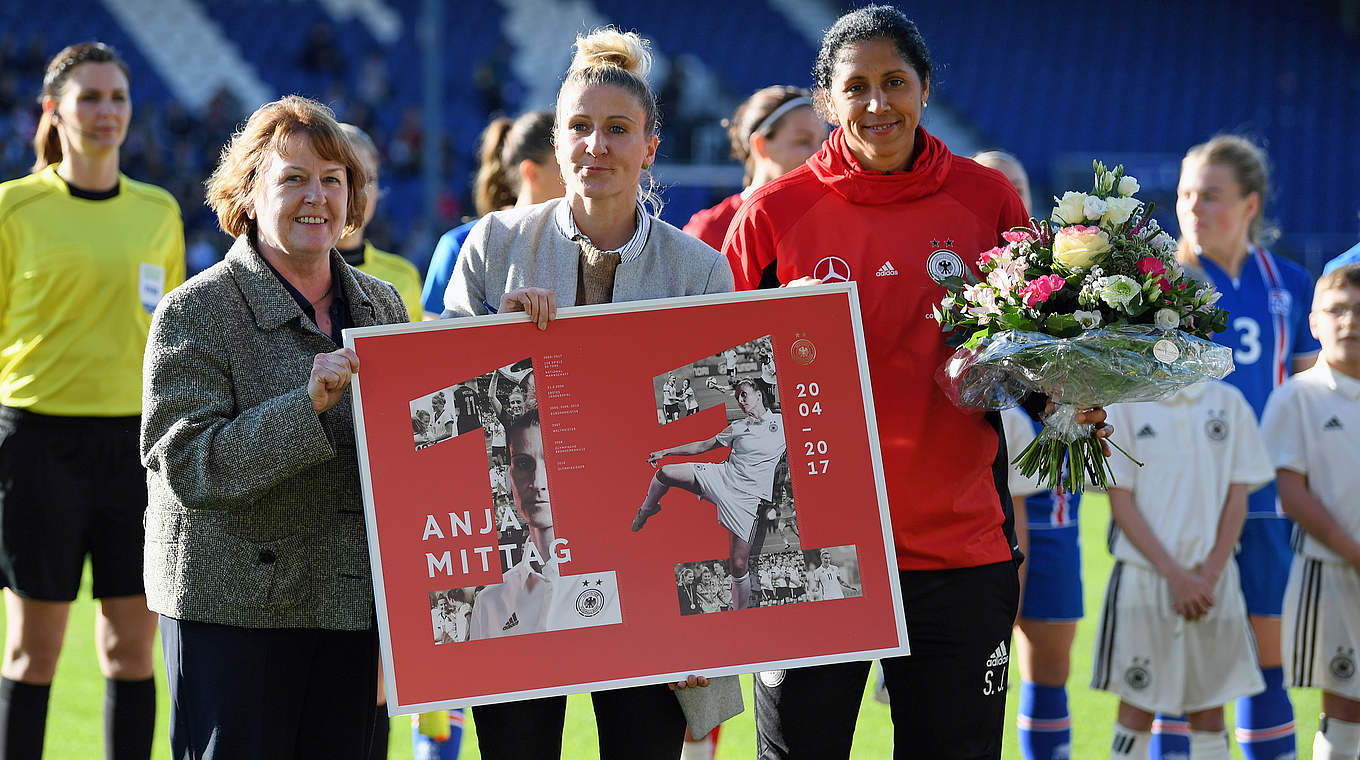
[0,166,186,417]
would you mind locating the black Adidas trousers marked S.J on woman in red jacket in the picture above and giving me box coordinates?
[755,562,1020,760]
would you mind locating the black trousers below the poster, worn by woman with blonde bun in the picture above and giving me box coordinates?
[472,684,685,760]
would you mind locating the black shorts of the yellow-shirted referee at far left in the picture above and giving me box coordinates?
[0,407,147,602]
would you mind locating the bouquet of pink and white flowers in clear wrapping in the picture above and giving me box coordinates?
[932,162,1232,492]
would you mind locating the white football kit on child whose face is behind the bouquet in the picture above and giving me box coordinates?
[1091,381,1274,715]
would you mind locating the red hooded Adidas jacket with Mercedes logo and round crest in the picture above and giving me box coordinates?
[722,126,1028,570]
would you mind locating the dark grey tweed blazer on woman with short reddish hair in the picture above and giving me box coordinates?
[141,235,407,631]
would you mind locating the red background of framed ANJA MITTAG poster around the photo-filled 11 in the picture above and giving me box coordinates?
[345,284,906,714]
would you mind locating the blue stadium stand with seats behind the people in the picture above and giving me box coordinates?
[0,0,1360,271]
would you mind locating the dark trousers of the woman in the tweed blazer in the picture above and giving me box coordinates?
[160,616,378,760]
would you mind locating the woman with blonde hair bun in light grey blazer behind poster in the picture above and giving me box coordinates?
[443,29,732,760]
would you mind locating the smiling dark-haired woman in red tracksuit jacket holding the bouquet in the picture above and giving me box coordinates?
[724,7,1104,759]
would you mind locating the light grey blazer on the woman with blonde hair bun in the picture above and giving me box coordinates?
[443,198,733,317]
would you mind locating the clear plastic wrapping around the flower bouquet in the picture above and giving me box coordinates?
[936,325,1232,413]
